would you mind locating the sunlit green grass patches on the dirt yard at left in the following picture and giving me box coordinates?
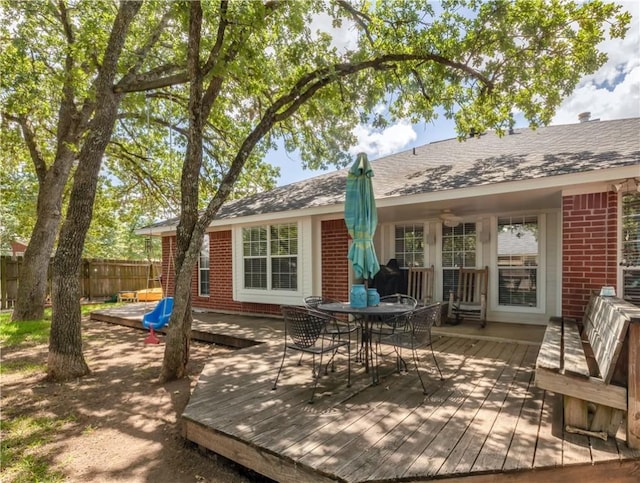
[0,303,119,483]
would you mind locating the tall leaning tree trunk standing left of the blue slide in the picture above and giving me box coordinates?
[47,1,141,381]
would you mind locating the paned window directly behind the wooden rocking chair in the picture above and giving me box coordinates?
[442,223,477,299]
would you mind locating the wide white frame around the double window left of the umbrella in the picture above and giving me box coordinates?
[232,218,313,305]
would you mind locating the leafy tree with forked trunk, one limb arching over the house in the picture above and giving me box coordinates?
[156,0,629,379]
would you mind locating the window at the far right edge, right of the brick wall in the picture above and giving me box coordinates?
[621,193,640,305]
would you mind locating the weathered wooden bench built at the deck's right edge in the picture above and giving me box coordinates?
[535,295,640,448]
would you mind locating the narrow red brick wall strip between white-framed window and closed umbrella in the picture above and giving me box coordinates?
[322,218,349,300]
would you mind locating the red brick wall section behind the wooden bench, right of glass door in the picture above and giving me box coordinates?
[562,192,618,319]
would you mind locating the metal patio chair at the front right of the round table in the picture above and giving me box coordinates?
[380,302,444,394]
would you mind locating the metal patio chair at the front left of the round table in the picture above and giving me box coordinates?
[272,305,351,404]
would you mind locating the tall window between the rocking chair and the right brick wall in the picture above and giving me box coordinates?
[497,216,540,307]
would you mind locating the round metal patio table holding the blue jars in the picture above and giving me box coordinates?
[316,302,413,384]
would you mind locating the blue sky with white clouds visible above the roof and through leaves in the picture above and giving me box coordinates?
[267,0,640,186]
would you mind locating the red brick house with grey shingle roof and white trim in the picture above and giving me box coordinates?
[148,118,640,324]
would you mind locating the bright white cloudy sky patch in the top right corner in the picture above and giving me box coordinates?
[552,1,640,124]
